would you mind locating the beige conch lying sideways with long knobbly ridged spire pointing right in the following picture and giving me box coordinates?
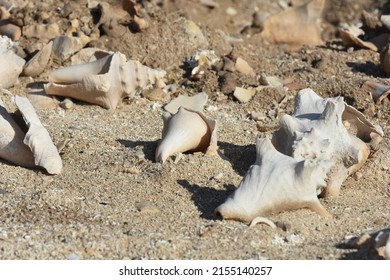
[45,52,165,109]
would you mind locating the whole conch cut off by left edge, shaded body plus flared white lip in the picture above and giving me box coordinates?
[0,96,62,174]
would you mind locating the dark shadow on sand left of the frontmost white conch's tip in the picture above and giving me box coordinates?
[177,180,236,220]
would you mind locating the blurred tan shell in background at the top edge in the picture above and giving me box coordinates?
[261,0,325,50]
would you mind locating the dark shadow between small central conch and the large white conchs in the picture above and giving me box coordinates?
[218,142,256,176]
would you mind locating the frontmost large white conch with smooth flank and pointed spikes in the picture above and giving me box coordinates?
[215,137,330,222]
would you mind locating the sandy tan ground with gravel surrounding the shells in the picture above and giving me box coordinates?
[0,0,390,259]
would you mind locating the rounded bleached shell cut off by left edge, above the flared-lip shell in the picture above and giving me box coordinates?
[0,46,25,89]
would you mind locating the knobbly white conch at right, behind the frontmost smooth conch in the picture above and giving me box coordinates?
[272,90,383,195]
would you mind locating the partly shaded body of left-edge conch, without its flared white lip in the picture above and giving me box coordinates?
[0,98,36,168]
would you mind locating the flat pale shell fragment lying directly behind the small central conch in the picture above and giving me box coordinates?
[164,91,208,114]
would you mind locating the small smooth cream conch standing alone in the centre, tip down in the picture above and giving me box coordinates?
[156,107,218,163]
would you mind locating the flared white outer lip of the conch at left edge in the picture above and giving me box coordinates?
[14,96,62,174]
